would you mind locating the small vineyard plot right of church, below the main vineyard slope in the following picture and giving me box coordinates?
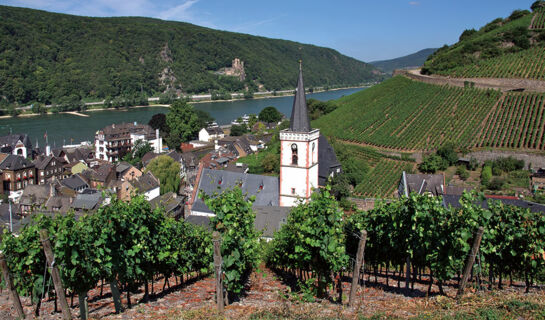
[336,144,416,198]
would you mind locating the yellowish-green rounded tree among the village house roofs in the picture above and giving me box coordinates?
[145,155,180,194]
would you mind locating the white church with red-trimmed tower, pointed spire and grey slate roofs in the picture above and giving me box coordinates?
[187,62,341,225]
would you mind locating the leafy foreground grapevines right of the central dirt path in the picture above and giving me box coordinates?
[266,191,545,304]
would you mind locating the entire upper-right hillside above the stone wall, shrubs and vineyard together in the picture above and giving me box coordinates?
[422,1,545,80]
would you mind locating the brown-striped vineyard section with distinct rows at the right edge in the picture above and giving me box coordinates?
[475,93,545,150]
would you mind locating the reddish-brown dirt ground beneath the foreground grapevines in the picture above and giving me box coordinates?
[0,266,545,320]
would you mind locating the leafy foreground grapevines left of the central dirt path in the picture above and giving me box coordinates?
[0,189,257,319]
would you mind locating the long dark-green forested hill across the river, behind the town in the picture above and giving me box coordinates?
[0,6,383,104]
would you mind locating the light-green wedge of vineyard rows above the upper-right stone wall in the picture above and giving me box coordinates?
[437,47,545,80]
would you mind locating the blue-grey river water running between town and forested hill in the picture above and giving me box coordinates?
[0,88,362,147]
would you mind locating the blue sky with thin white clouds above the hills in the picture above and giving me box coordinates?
[0,0,534,62]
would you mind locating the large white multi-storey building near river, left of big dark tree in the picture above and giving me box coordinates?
[95,122,163,162]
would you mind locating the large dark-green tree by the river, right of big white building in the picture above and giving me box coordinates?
[166,100,202,149]
